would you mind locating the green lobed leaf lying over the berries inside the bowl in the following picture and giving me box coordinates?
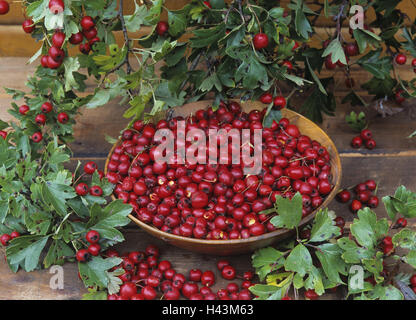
[270,192,302,229]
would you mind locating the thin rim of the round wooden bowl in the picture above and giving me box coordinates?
[104,100,342,246]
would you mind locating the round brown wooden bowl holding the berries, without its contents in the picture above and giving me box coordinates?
[105,100,341,256]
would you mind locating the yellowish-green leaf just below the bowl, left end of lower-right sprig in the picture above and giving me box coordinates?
[251,247,284,281]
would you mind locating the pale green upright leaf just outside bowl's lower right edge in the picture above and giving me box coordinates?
[309,208,341,242]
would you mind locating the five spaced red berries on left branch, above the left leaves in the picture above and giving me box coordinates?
[19,101,69,143]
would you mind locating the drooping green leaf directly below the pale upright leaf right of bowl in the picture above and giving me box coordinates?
[315,243,348,284]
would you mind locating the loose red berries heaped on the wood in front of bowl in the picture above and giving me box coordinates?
[105,245,254,300]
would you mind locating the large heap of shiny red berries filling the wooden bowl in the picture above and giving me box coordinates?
[106,102,333,240]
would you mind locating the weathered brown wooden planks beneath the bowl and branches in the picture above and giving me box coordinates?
[0,54,416,299]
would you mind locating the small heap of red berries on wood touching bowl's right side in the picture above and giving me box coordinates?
[336,180,379,213]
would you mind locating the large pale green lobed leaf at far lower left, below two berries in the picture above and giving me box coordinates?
[6,235,49,272]
